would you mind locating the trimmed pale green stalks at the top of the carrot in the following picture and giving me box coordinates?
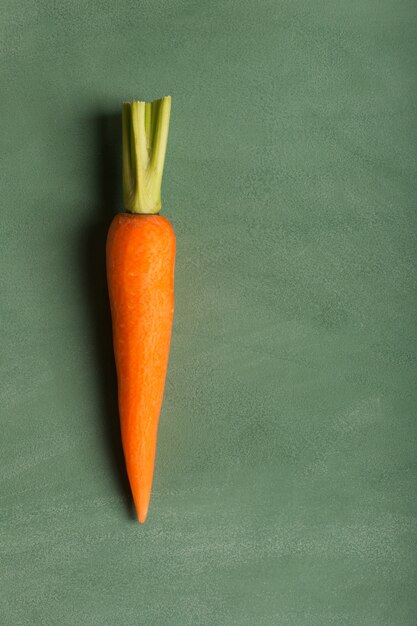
[122,96,171,214]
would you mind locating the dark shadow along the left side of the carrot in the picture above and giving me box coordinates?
[82,114,135,519]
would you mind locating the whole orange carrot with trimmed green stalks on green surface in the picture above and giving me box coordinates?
[106,96,175,523]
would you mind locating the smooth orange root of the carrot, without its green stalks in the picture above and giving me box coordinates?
[106,213,175,523]
